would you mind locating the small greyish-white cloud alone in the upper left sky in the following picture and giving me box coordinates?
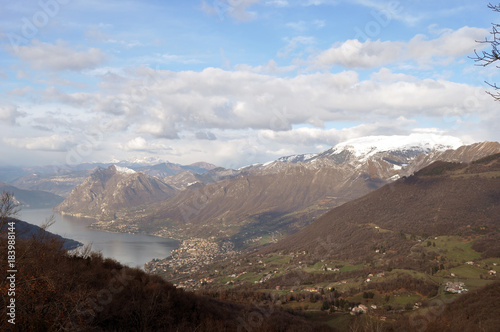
[16,40,106,71]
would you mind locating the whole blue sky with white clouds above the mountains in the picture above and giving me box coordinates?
[0,0,500,168]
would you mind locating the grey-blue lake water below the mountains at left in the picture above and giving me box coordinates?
[17,209,178,268]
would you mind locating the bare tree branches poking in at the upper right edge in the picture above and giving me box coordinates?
[471,3,500,101]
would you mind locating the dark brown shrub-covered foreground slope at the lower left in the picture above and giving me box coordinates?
[0,222,336,331]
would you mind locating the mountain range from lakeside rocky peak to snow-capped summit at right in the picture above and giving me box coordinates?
[57,134,500,244]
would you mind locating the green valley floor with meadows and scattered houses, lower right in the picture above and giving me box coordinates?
[156,236,500,328]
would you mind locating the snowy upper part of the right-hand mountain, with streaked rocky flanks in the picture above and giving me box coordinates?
[250,133,463,185]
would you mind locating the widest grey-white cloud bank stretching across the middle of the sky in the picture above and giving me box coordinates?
[35,67,494,144]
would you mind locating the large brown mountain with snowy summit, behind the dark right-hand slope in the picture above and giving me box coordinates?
[109,134,500,238]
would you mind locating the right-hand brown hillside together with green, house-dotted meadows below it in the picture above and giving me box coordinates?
[143,150,500,330]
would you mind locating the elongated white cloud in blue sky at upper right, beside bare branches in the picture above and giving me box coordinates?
[312,27,488,68]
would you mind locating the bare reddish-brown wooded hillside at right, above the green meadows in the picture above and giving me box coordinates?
[264,154,500,261]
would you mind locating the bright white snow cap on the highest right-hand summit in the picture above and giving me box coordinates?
[333,133,463,158]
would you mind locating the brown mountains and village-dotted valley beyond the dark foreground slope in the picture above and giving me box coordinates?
[2,137,500,331]
